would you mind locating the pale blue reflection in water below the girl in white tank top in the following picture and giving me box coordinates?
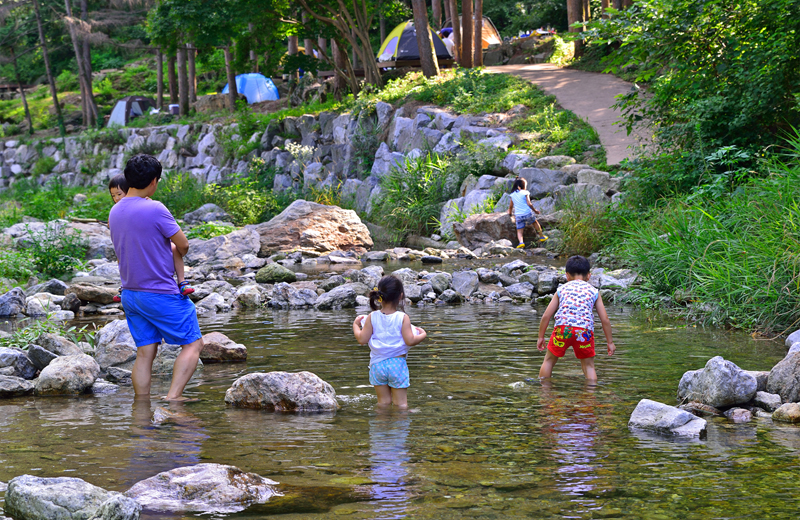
[369,406,411,520]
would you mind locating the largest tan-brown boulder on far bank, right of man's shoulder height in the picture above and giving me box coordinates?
[255,200,372,256]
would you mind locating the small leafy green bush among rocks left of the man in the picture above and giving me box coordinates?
[25,223,88,278]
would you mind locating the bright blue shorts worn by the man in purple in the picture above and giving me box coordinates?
[122,289,203,348]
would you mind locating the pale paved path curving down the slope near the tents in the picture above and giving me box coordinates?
[486,63,637,164]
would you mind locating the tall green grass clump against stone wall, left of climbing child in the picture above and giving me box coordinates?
[373,150,466,239]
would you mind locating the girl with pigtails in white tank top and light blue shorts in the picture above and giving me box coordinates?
[353,276,428,408]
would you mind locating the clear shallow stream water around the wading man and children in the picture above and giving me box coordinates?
[0,290,800,520]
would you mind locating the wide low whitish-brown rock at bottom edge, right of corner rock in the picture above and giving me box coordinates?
[125,464,282,513]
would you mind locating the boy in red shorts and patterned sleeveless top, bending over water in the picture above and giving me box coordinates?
[536,255,617,383]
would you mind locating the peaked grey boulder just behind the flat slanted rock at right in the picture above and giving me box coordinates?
[678,356,758,408]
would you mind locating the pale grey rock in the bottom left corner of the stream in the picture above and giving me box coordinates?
[5,475,142,520]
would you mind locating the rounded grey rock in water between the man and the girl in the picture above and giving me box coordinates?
[225,372,339,412]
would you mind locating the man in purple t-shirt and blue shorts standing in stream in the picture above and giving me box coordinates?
[108,154,203,400]
